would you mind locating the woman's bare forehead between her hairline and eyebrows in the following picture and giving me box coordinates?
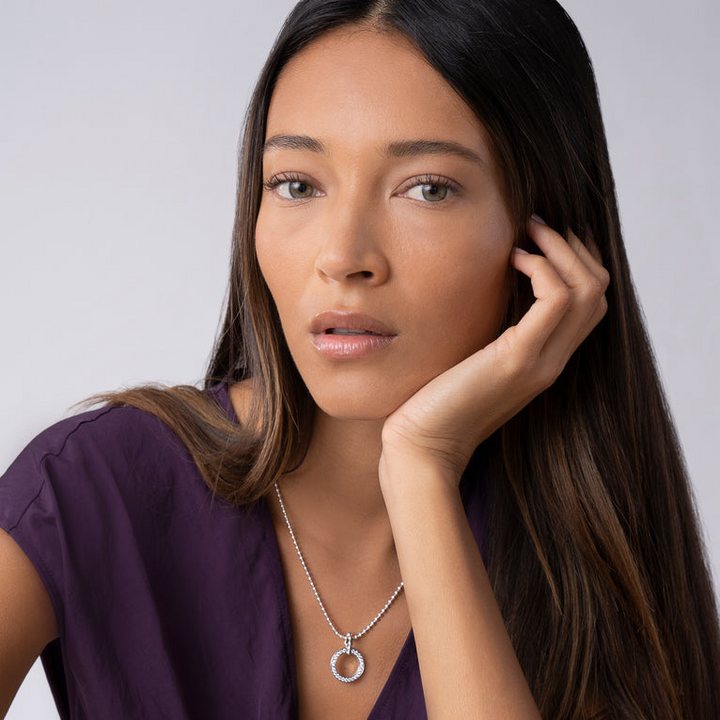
[267,27,490,162]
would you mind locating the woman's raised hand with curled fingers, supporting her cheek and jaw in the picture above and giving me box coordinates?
[383,217,610,481]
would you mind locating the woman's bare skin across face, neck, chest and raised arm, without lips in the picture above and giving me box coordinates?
[253,23,609,718]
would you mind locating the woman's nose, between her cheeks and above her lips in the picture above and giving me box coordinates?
[315,205,390,286]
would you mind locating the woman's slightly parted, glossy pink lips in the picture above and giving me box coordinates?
[310,310,397,360]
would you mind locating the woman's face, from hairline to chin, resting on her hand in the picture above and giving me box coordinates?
[256,28,513,419]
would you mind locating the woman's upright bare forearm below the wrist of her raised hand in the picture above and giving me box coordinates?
[380,458,539,720]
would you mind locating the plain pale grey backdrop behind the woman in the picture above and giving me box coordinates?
[0,0,720,720]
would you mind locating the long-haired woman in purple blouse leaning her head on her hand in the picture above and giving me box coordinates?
[0,0,719,718]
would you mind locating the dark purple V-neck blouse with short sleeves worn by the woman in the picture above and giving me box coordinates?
[0,386,482,720]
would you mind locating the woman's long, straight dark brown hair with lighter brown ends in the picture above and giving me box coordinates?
[106,0,720,720]
